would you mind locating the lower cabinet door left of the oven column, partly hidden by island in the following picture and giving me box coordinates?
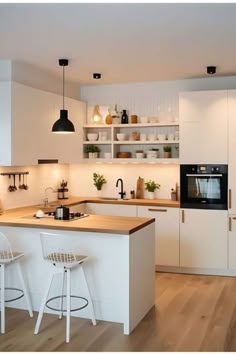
[137,206,179,267]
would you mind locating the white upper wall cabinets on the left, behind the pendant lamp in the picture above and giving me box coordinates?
[0,82,86,166]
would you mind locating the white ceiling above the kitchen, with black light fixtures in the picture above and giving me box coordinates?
[0,3,236,85]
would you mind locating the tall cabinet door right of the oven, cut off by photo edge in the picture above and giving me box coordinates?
[228,90,236,214]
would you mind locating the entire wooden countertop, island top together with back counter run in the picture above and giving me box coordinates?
[0,197,180,235]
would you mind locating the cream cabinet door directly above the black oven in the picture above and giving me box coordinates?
[179,90,228,164]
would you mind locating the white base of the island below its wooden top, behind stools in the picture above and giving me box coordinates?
[0,223,155,334]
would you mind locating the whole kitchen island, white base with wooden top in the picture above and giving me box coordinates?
[0,207,155,334]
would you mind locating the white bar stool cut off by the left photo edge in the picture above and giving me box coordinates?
[0,232,33,334]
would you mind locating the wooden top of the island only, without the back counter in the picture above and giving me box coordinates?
[0,203,155,235]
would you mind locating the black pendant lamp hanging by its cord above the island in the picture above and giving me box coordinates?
[52,59,75,134]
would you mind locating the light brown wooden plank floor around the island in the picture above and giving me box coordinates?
[0,273,236,352]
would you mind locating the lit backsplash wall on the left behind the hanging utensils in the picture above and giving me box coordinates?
[0,164,69,209]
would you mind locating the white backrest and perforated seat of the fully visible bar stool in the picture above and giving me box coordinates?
[40,232,76,265]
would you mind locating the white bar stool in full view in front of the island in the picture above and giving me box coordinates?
[34,233,96,343]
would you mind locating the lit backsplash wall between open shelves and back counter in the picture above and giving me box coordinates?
[70,164,179,199]
